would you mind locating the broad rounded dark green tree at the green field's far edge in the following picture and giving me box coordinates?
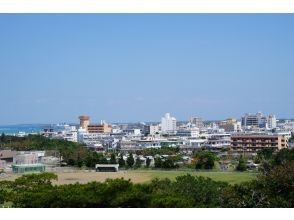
[194,150,217,169]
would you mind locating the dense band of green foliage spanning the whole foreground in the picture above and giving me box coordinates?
[0,150,294,208]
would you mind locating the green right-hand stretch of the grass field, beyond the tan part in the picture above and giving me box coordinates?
[128,170,257,184]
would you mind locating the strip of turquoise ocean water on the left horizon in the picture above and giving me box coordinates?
[0,124,48,135]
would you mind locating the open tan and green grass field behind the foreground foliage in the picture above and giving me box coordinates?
[0,170,256,185]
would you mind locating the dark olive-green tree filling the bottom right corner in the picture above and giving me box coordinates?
[222,161,294,208]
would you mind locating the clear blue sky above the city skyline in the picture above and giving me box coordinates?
[0,14,294,124]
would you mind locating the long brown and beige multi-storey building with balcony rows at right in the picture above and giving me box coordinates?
[231,134,289,152]
